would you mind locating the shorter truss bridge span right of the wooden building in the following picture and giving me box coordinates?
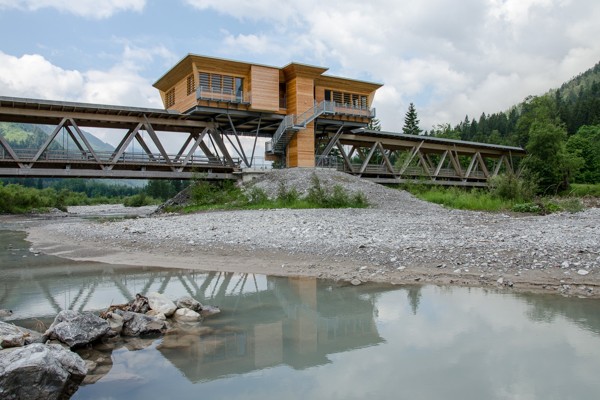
[317,130,525,186]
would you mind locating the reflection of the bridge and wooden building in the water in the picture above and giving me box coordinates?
[0,233,391,382]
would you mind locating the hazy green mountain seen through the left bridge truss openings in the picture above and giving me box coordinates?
[0,122,114,151]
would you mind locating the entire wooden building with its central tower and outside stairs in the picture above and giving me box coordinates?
[154,54,382,167]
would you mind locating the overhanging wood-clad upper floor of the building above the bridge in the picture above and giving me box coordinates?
[154,54,382,124]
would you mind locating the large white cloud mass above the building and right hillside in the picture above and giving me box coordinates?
[186,0,600,130]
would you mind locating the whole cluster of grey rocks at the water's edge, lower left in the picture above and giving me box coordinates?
[0,293,220,399]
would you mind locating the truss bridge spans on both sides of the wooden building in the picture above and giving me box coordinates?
[0,96,525,186]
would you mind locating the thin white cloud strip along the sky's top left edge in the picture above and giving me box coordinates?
[0,0,146,19]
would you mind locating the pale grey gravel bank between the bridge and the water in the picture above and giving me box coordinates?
[23,169,600,297]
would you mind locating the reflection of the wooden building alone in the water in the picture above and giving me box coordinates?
[157,277,383,382]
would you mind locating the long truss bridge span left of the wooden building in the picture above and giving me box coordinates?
[0,98,250,179]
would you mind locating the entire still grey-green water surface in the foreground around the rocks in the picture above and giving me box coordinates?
[0,230,600,400]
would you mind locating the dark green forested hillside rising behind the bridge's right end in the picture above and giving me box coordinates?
[427,63,600,189]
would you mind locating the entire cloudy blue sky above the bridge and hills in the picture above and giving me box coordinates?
[0,0,600,136]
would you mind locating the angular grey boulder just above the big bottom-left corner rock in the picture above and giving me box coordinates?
[45,310,110,348]
